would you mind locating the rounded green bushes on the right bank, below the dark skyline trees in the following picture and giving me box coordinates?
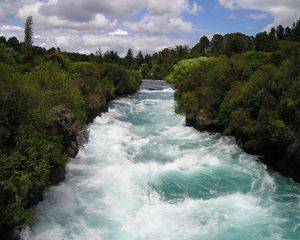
[168,39,300,159]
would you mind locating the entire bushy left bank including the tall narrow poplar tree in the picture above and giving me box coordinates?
[0,17,141,239]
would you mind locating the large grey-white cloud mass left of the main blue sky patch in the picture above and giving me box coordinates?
[0,0,203,53]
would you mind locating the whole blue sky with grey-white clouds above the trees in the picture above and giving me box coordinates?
[0,0,300,56]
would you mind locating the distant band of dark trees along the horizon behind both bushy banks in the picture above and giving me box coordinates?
[0,21,300,79]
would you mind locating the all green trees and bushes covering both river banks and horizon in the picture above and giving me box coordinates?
[0,14,300,239]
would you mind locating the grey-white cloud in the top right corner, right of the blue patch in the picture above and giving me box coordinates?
[219,0,300,29]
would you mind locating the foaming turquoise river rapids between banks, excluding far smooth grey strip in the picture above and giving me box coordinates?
[23,81,300,240]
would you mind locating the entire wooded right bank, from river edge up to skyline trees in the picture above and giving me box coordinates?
[167,21,300,181]
